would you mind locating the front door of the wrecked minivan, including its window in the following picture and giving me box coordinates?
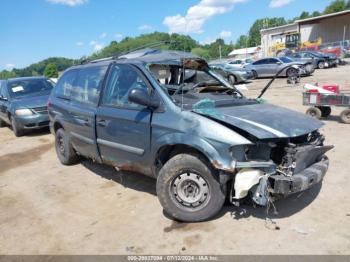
[96,64,152,174]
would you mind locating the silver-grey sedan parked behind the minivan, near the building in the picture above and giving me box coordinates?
[244,57,313,78]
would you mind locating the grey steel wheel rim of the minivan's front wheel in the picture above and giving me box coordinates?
[172,172,209,207]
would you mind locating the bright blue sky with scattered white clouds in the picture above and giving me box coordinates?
[0,0,331,70]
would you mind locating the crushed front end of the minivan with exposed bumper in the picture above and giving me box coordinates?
[231,131,333,206]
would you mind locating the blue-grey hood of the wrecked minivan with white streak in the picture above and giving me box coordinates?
[193,104,323,139]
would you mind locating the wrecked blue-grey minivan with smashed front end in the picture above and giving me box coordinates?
[48,49,332,222]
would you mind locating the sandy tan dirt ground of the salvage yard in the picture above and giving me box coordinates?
[0,66,350,255]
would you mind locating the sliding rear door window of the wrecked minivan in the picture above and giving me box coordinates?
[70,66,107,105]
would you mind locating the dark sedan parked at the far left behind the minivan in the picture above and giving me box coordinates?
[0,77,54,136]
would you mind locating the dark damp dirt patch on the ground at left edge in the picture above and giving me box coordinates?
[0,143,52,174]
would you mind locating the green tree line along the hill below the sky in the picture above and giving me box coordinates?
[0,0,350,79]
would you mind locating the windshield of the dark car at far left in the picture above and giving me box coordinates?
[8,78,53,98]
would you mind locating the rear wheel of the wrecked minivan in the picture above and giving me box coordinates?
[55,128,79,165]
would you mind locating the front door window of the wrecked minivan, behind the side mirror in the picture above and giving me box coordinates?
[102,64,148,109]
